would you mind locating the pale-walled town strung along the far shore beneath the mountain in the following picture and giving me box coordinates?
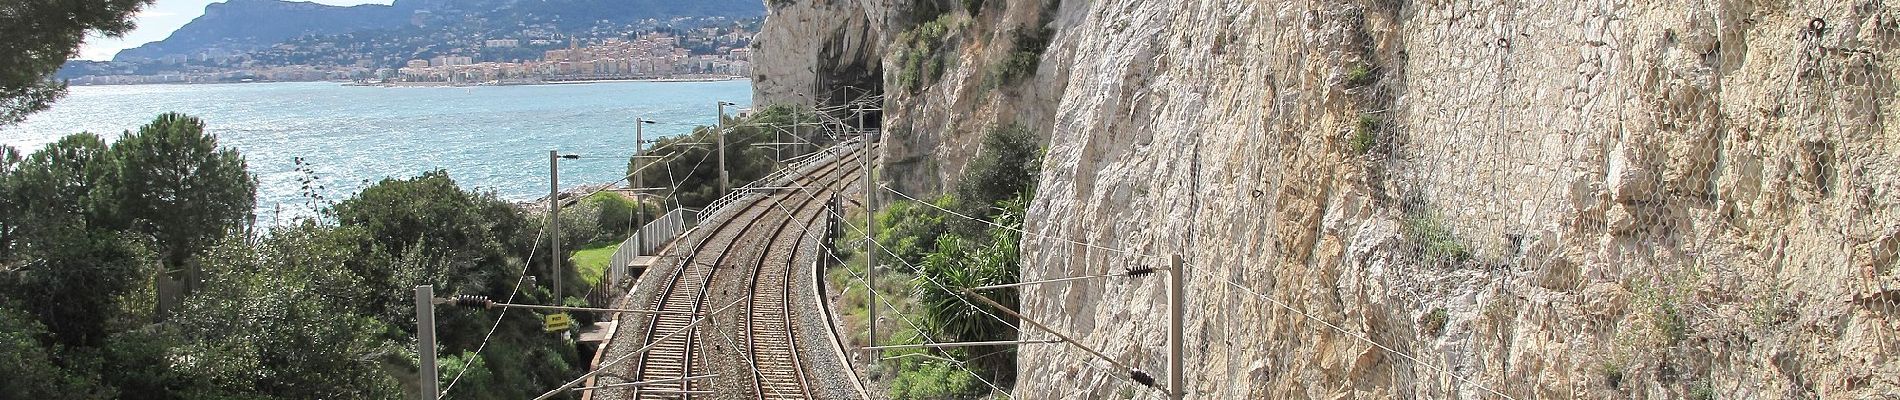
[63,21,756,85]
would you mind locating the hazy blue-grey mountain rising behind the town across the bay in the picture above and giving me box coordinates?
[114,0,766,61]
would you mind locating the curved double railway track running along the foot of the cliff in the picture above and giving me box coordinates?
[629,142,865,398]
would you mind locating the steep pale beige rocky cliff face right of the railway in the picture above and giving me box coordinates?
[766,0,1900,398]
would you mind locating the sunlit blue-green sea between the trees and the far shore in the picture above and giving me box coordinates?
[0,80,752,226]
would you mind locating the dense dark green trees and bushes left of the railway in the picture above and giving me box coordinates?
[0,112,581,400]
